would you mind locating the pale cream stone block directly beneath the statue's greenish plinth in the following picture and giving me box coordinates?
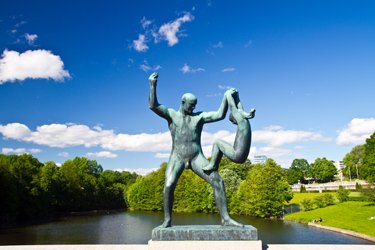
[148,240,262,250]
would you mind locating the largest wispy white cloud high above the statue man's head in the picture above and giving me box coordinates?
[158,12,194,46]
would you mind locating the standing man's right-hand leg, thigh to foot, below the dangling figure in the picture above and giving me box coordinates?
[192,154,243,226]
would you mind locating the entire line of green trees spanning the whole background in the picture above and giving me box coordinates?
[0,133,375,223]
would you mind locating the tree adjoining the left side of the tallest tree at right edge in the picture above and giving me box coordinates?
[342,145,365,178]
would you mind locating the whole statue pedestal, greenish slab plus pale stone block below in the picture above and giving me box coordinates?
[148,225,262,250]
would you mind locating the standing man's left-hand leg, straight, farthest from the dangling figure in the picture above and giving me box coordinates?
[161,155,184,227]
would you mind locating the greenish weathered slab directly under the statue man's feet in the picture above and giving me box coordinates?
[151,225,258,241]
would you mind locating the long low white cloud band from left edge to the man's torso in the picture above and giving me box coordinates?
[0,123,172,152]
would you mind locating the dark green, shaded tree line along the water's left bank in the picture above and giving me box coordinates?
[0,154,138,224]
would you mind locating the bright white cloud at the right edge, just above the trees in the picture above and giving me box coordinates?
[336,118,375,146]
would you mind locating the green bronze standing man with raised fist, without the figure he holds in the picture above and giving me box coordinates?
[149,73,242,227]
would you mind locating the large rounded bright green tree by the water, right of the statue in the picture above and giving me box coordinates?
[231,159,293,217]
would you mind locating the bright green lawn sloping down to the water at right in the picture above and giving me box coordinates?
[284,201,375,236]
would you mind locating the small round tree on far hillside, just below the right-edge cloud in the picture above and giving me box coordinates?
[309,157,337,182]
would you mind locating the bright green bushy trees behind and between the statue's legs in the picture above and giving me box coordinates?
[126,158,293,218]
